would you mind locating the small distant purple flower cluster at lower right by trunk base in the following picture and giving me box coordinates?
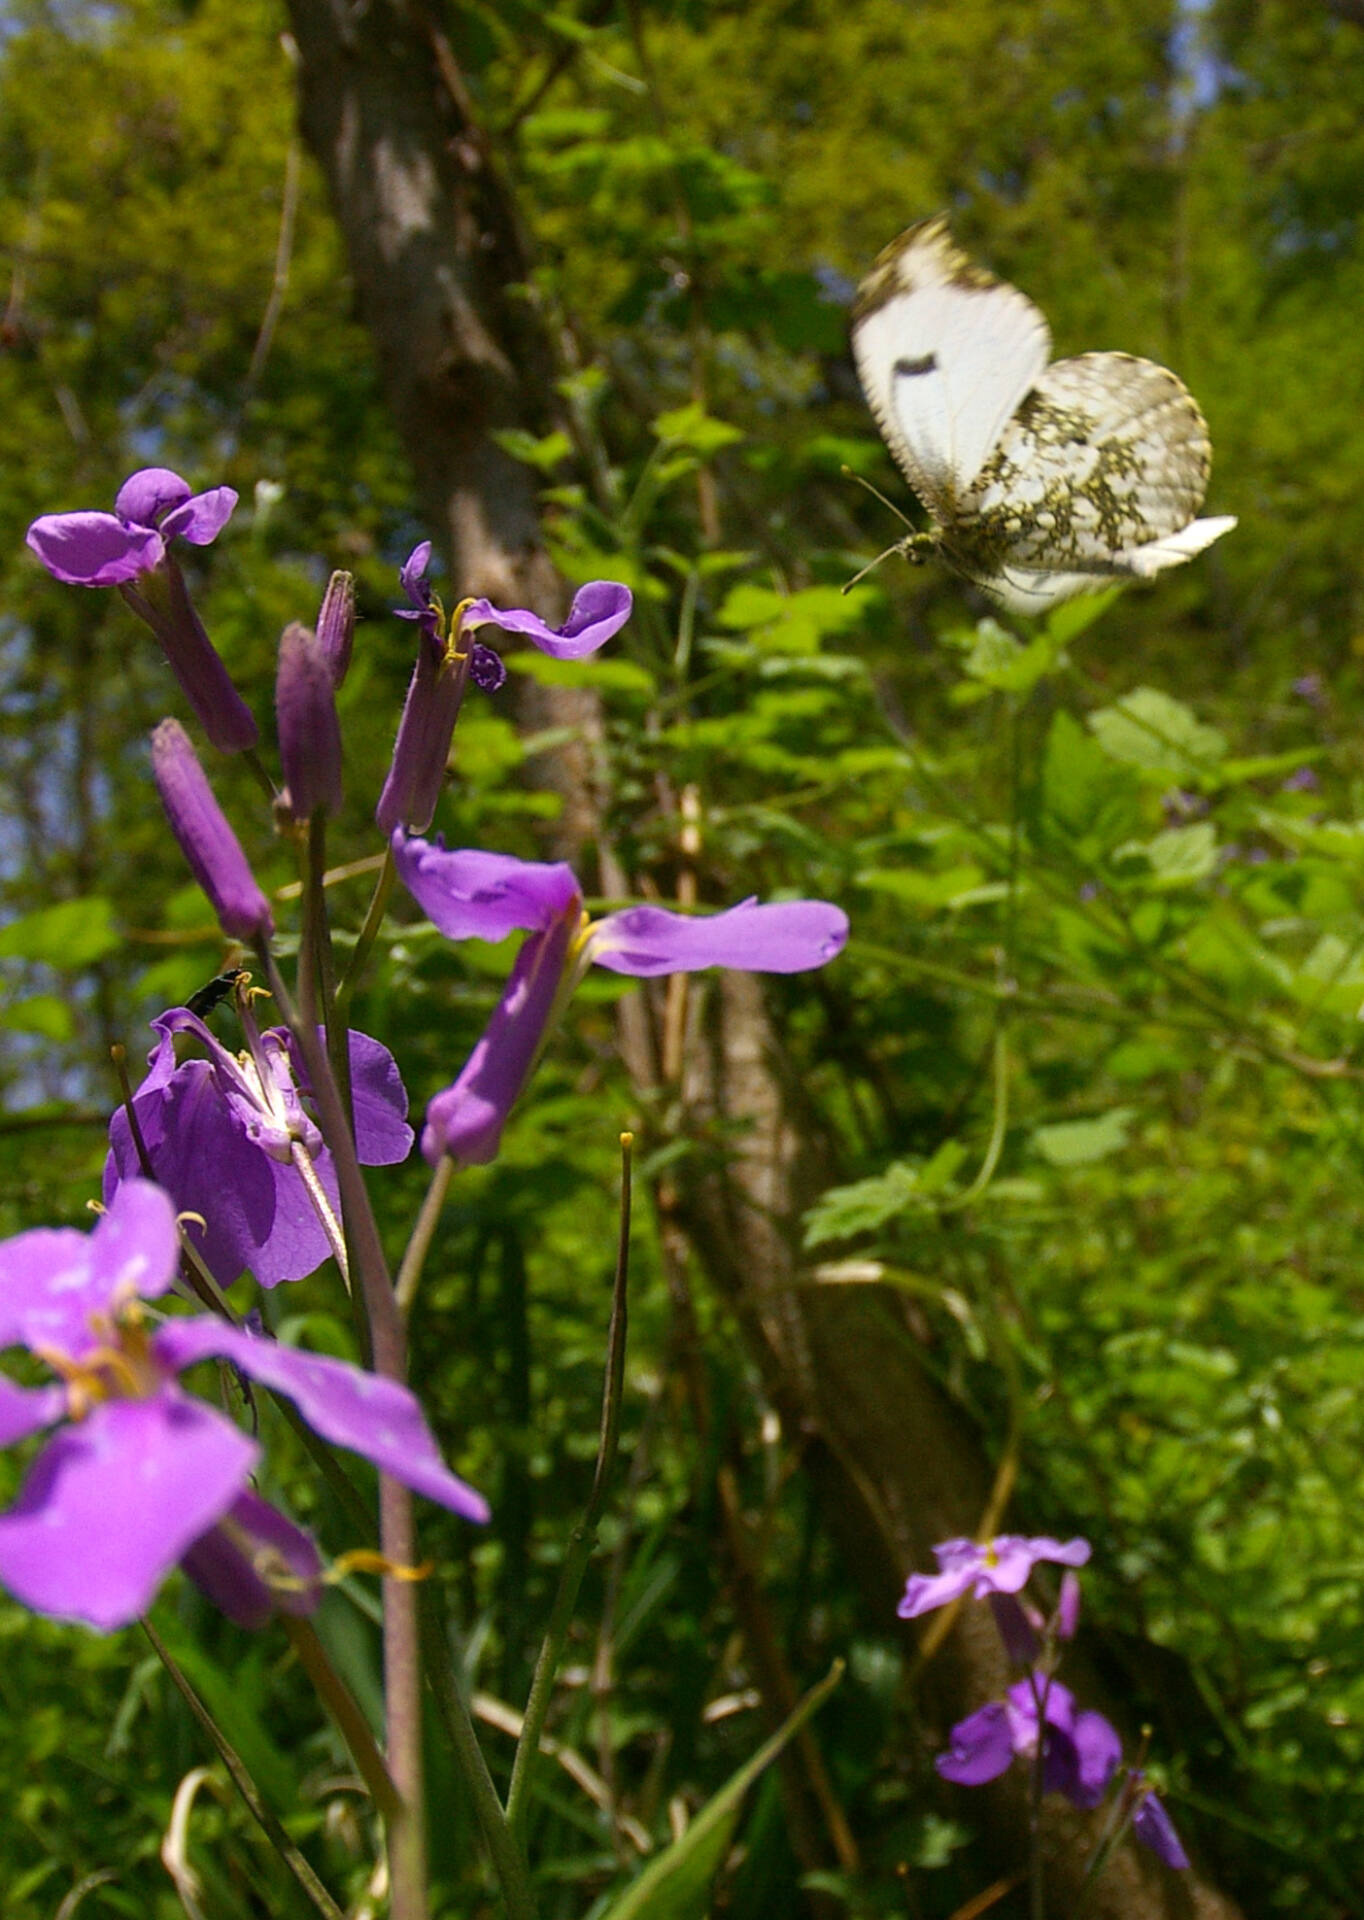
[914,1534,1189,1868]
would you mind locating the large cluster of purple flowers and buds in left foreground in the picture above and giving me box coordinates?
[13,483,847,1681]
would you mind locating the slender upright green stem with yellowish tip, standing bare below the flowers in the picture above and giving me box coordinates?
[507,1133,634,1843]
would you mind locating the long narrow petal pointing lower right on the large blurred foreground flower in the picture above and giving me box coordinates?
[154,1319,488,1521]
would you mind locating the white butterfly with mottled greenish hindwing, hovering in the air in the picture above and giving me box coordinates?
[853,213,1235,612]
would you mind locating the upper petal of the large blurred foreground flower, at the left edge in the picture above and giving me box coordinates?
[0,1179,181,1357]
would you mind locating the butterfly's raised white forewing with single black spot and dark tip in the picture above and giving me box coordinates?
[853,215,1051,524]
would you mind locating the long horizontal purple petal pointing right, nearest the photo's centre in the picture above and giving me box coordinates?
[588,900,847,977]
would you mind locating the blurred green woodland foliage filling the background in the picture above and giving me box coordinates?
[0,0,1364,1920]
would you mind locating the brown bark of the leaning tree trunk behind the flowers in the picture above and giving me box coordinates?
[288,0,1237,1920]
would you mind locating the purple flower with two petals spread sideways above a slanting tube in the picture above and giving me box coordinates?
[392,833,847,1165]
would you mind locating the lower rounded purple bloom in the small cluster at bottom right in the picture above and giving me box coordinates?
[934,1680,1122,1807]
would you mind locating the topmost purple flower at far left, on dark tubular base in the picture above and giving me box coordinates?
[27,467,257,753]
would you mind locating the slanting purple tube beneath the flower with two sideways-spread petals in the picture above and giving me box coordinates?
[421,906,578,1167]
